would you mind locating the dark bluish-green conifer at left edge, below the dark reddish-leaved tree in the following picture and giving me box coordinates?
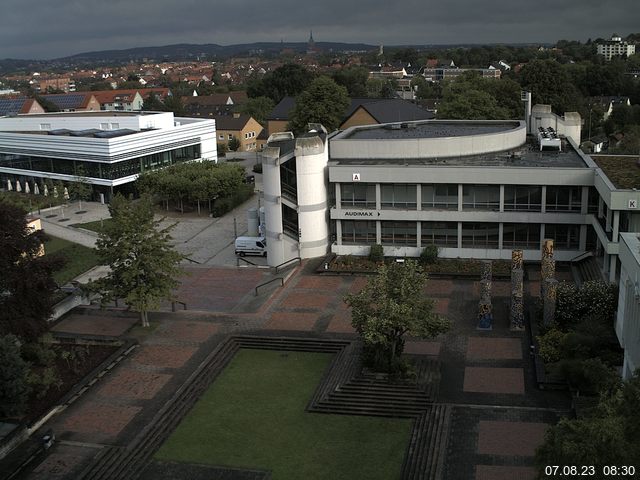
[0,335,29,418]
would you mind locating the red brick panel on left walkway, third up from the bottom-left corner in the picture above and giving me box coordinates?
[99,368,171,400]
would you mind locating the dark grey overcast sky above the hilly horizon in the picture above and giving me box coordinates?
[0,0,640,59]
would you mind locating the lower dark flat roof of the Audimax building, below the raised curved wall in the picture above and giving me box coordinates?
[329,137,590,168]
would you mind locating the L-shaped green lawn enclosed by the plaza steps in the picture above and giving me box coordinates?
[156,349,411,480]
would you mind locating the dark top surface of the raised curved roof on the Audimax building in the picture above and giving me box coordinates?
[339,120,520,140]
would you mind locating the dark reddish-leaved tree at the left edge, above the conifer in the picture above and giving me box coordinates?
[0,200,61,341]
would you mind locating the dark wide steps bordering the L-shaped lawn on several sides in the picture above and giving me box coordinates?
[78,336,451,480]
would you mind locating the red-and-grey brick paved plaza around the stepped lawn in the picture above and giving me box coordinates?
[16,253,569,480]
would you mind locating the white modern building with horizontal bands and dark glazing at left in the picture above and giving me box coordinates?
[0,112,217,199]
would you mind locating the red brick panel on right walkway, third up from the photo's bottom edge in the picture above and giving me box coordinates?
[463,367,524,395]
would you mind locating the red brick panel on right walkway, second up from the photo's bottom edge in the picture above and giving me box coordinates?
[478,421,548,457]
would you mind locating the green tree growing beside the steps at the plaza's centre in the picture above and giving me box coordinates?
[345,260,451,372]
